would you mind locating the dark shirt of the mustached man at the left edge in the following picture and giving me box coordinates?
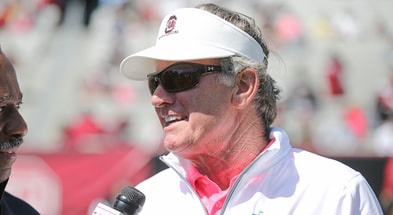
[0,180,39,215]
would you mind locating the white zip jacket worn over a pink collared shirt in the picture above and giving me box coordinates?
[136,128,382,215]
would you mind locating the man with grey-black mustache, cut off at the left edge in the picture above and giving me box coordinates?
[0,47,39,215]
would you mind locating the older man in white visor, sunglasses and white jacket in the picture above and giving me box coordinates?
[120,4,382,215]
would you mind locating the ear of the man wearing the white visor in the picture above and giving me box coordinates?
[232,68,259,108]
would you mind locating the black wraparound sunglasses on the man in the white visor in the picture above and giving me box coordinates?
[147,62,221,94]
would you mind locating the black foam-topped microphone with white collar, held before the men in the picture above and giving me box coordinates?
[92,186,146,215]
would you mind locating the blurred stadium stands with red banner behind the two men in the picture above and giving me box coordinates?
[0,0,393,215]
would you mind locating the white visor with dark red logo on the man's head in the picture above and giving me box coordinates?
[120,8,265,80]
